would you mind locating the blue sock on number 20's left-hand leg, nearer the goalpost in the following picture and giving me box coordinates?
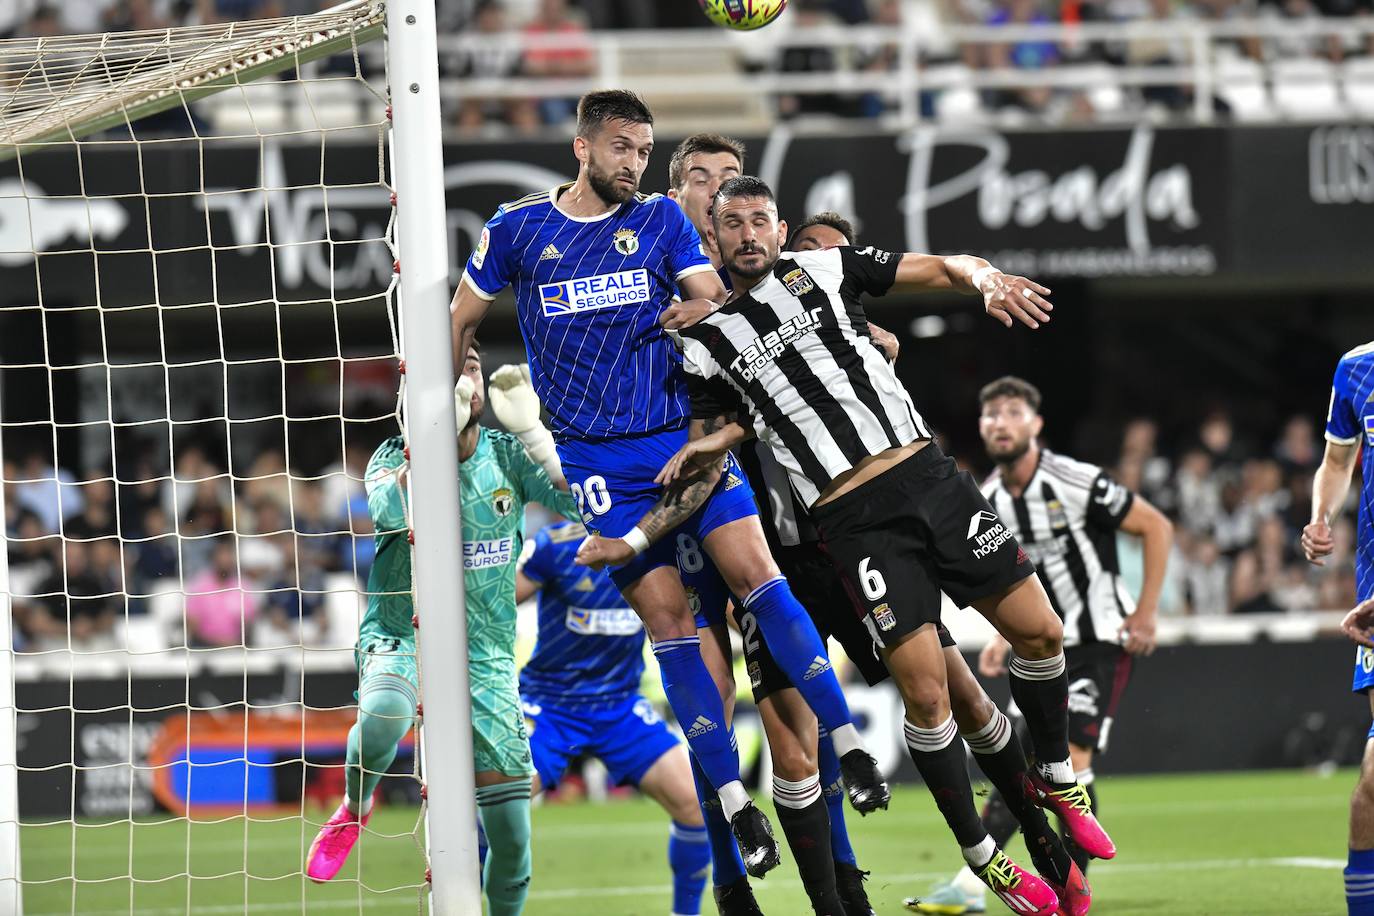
[654,636,739,788]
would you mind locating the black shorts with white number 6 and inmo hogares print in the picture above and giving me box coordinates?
[811,442,1035,645]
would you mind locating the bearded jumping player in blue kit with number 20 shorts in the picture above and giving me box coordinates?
[451,91,889,876]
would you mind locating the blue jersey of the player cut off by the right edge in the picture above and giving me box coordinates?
[1326,341,1374,602]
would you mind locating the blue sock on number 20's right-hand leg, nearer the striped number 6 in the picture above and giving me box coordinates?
[745,575,851,732]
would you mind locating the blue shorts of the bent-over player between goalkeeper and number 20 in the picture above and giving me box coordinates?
[521,695,679,788]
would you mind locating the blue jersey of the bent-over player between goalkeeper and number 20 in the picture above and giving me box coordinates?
[519,522,644,706]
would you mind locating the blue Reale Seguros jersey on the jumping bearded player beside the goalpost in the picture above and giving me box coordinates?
[463,184,713,439]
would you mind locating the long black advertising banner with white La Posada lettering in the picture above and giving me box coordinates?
[0,125,1374,308]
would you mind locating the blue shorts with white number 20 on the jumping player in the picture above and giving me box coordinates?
[558,427,758,588]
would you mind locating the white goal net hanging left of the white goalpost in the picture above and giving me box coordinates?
[0,0,472,915]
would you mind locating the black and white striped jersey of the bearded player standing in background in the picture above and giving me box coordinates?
[982,449,1135,645]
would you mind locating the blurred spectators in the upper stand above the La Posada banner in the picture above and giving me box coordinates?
[0,0,1374,132]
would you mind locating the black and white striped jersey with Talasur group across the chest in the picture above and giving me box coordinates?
[679,247,930,507]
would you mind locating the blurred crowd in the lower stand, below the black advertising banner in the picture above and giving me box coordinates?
[4,401,1355,651]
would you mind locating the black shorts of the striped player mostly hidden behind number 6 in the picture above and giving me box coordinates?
[735,544,958,703]
